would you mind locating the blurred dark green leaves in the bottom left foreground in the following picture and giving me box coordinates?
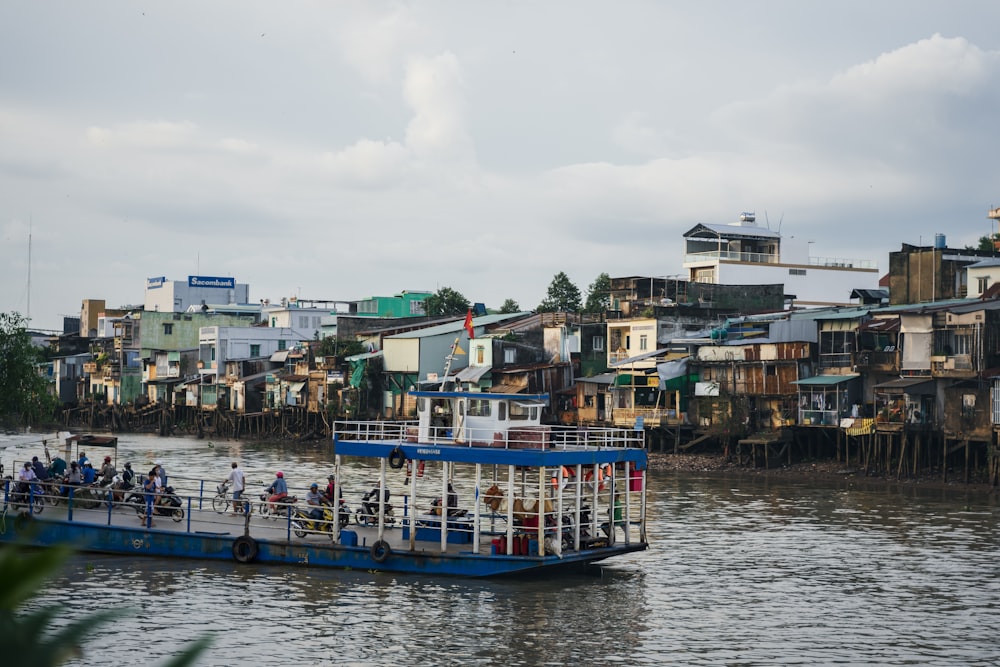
[0,544,211,667]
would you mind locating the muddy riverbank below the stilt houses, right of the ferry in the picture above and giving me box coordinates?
[649,452,1000,497]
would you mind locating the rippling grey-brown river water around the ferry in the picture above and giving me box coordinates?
[0,435,1000,665]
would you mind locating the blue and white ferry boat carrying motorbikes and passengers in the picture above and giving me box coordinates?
[0,391,648,577]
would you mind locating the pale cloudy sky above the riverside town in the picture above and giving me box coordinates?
[0,0,1000,329]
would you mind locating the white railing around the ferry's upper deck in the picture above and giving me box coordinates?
[334,421,645,450]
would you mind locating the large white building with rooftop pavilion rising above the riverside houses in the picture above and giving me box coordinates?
[684,213,879,307]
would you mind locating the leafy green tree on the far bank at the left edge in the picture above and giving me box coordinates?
[0,313,56,426]
